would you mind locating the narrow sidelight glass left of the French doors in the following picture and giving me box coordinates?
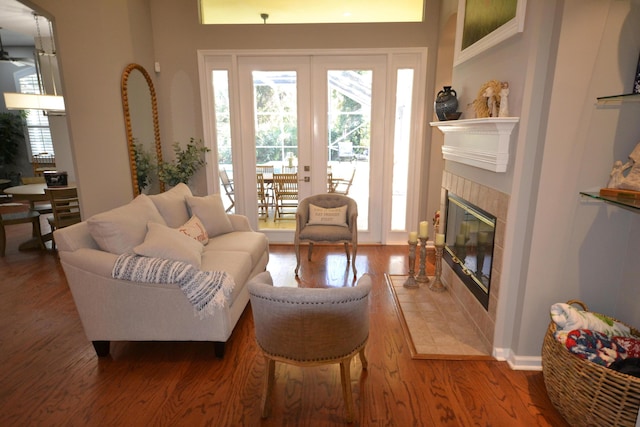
[213,70,235,216]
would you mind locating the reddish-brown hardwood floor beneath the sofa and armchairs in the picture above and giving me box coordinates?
[0,226,567,427]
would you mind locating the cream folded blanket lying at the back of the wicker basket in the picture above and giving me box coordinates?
[551,303,631,337]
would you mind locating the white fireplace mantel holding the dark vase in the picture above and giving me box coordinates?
[430,117,520,172]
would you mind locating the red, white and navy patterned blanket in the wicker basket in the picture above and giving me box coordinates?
[565,329,627,366]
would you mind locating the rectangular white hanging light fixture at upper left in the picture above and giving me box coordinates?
[4,13,65,113]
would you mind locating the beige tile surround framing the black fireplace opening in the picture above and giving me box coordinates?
[441,171,509,348]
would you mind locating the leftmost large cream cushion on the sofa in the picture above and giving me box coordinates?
[87,194,166,255]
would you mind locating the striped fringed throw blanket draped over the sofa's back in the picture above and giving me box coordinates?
[111,254,235,318]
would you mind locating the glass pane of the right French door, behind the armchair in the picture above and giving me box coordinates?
[327,70,373,230]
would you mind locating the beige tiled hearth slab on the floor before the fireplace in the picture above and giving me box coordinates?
[385,274,493,360]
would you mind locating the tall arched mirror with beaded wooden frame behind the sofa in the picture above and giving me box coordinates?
[121,64,164,197]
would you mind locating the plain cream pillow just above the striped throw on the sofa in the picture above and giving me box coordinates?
[133,222,204,268]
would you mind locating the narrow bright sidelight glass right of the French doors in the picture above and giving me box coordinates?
[391,69,413,231]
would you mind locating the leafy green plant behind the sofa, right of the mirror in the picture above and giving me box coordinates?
[158,138,211,187]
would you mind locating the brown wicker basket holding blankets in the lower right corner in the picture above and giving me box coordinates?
[542,300,640,427]
